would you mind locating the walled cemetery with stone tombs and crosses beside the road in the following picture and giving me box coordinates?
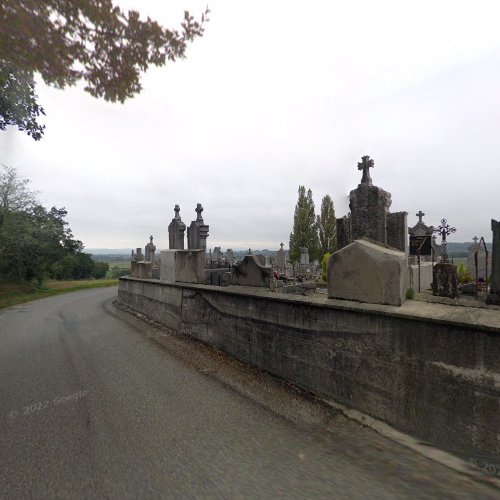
[118,156,500,464]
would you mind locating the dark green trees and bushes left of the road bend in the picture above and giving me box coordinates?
[0,165,109,284]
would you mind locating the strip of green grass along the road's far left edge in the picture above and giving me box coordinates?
[0,278,118,309]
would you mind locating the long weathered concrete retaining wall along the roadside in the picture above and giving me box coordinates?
[118,277,500,458]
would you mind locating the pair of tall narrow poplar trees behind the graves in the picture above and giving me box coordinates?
[289,186,337,263]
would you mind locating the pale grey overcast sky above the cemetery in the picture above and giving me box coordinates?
[0,0,500,250]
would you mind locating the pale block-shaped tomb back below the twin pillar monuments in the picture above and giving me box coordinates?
[160,249,205,283]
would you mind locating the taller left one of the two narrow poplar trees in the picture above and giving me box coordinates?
[288,186,319,263]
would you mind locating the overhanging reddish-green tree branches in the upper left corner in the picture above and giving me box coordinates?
[0,0,209,140]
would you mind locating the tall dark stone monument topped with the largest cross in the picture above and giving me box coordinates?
[336,156,408,253]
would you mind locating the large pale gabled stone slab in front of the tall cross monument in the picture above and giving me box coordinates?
[327,240,408,306]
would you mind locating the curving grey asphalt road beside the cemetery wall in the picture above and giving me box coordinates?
[0,287,498,499]
